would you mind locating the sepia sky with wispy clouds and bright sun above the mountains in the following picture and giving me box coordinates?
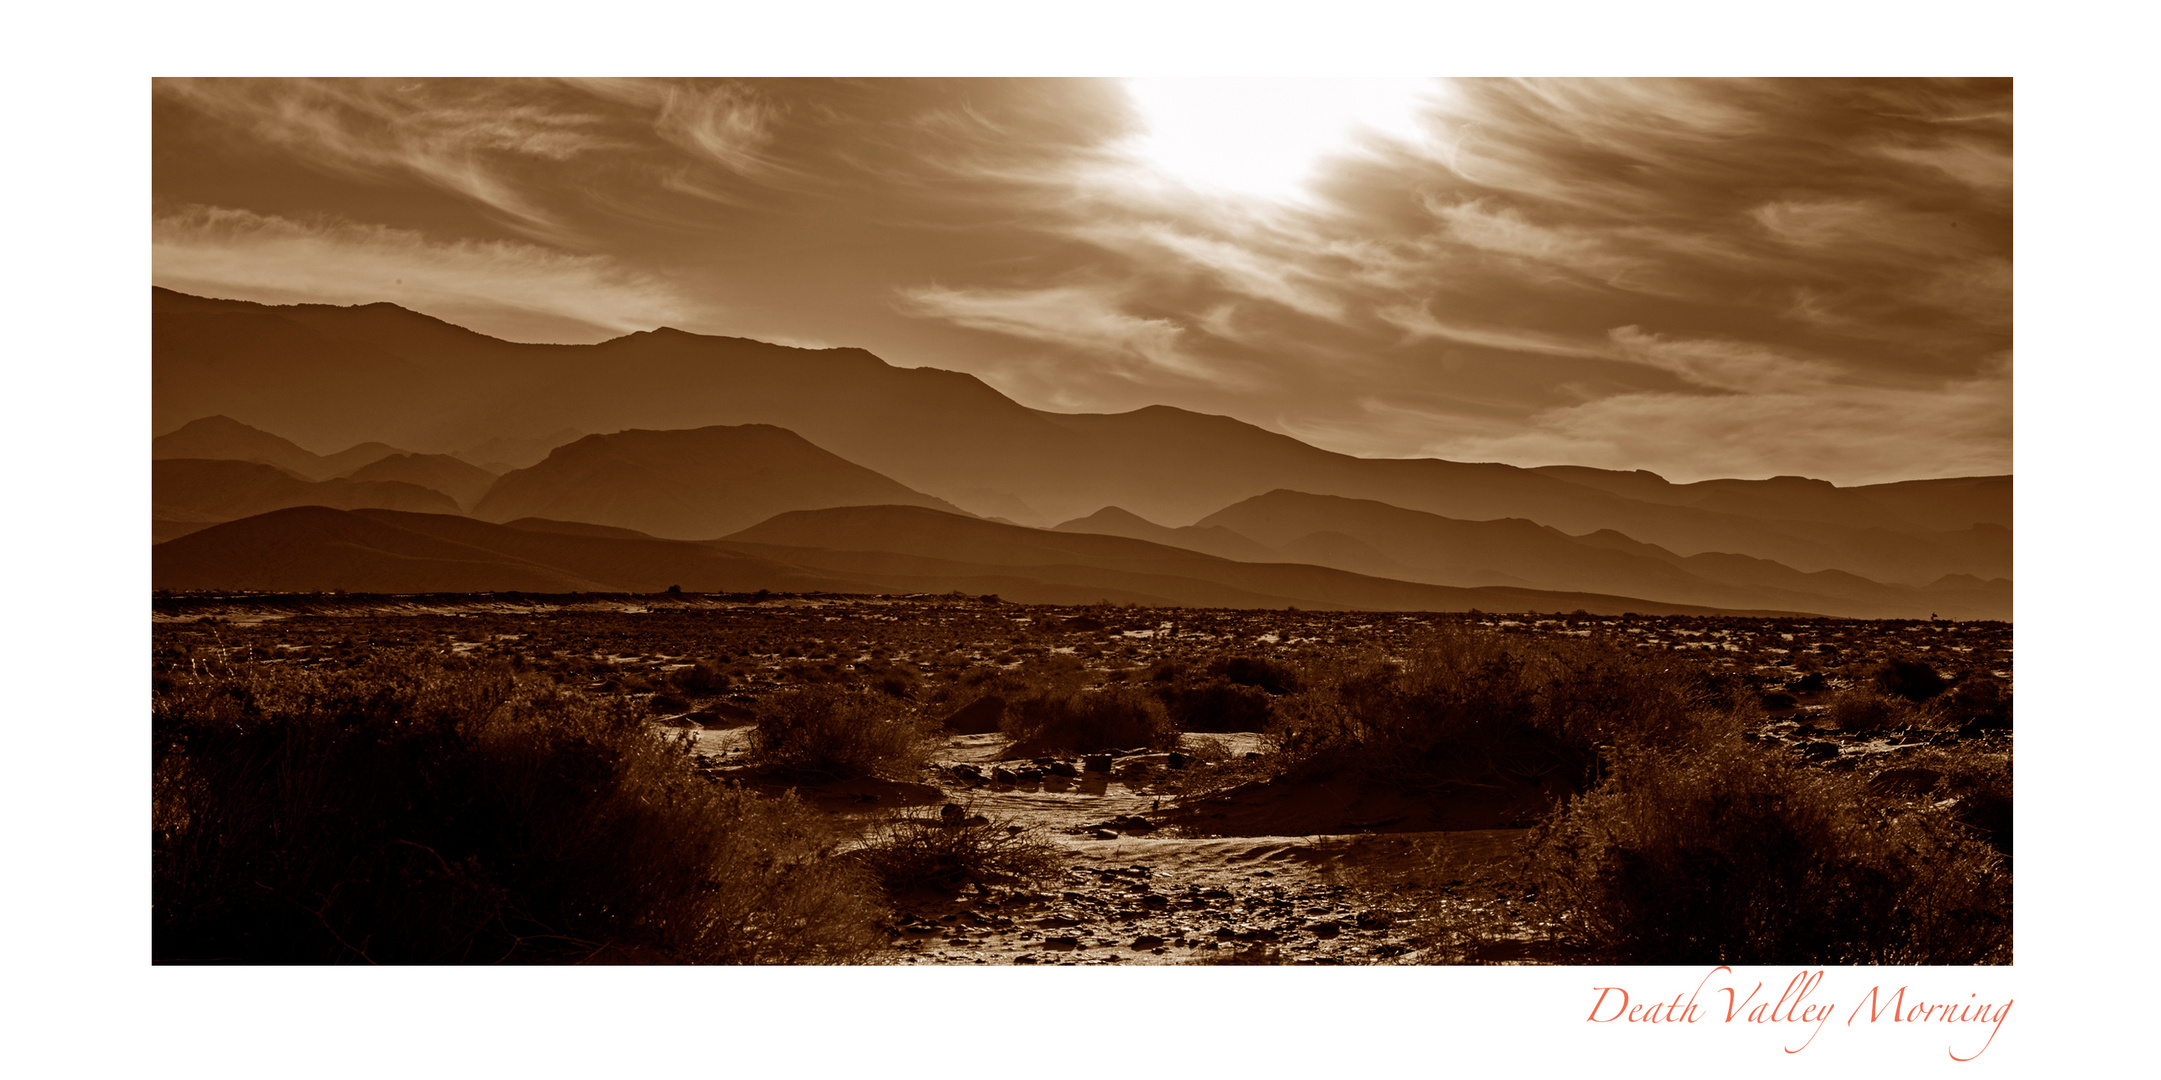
[151,78,2012,484]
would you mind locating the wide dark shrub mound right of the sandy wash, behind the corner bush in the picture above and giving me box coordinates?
[1273,629,1720,786]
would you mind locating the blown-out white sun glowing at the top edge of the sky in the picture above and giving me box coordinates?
[1126,78,1444,201]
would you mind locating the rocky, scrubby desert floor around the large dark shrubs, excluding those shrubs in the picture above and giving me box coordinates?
[153,594,2012,966]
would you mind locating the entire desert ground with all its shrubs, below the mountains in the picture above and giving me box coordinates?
[153,594,2012,963]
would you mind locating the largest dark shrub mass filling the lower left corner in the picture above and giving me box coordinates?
[151,654,880,963]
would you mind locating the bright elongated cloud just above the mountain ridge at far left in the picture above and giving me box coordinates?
[151,207,700,341]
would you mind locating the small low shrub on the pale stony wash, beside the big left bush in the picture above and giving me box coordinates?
[849,812,1059,894]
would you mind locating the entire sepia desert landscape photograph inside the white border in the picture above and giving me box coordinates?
[149,78,2016,976]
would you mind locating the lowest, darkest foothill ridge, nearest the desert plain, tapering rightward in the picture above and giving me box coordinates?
[151,505,1789,613]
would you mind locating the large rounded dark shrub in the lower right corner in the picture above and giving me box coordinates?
[1532,745,2012,963]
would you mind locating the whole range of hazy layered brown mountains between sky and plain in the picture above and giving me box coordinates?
[153,289,2012,618]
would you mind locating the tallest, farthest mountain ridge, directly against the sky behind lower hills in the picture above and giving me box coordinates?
[153,289,2012,588]
